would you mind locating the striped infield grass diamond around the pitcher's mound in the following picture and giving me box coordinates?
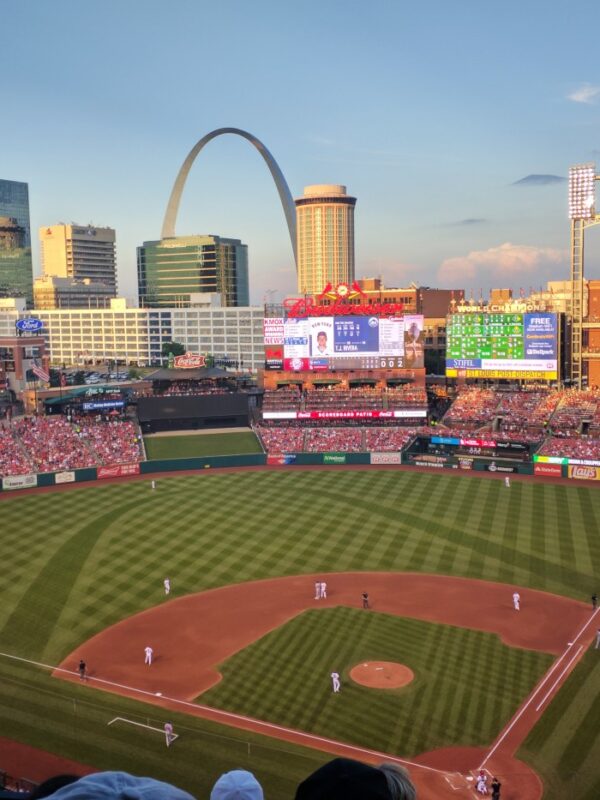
[199,607,553,757]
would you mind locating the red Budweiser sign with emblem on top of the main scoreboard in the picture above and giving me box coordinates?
[283,281,404,319]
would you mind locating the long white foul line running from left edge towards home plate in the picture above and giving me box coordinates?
[0,652,448,776]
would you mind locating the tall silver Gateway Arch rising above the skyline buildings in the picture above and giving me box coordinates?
[161,128,298,271]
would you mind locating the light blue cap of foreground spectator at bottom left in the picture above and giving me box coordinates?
[35,772,195,800]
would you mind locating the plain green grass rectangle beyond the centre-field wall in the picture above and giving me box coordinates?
[144,431,262,460]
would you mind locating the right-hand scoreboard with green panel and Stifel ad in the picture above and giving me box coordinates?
[446,311,558,381]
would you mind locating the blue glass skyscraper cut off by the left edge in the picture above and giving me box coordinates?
[0,179,33,306]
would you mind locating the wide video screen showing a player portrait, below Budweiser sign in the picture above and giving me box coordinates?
[264,314,424,372]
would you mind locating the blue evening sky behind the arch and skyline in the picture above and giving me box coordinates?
[0,0,600,304]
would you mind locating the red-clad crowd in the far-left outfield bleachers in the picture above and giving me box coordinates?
[0,415,143,477]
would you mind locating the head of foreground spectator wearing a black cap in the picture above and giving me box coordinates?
[296,758,417,800]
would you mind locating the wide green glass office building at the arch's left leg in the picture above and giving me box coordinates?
[137,236,250,308]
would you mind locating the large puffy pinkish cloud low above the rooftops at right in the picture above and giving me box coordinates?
[438,242,568,285]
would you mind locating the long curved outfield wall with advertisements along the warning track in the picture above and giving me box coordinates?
[0,452,576,492]
